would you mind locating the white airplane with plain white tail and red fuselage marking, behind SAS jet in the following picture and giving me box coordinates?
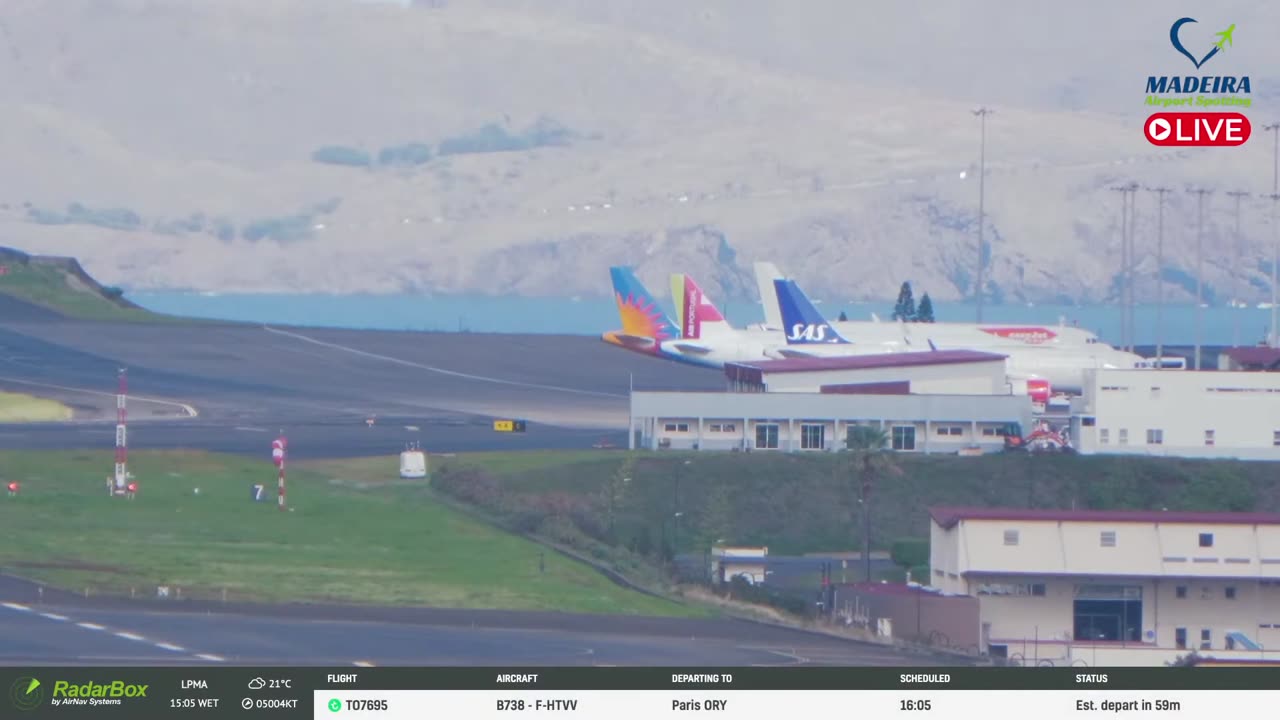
[755,263,1105,350]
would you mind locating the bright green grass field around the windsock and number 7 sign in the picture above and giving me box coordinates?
[0,451,699,615]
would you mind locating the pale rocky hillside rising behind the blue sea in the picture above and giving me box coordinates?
[0,0,1280,301]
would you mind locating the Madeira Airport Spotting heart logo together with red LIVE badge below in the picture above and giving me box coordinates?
[1143,18,1253,147]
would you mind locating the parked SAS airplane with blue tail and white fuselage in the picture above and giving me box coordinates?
[773,274,1143,395]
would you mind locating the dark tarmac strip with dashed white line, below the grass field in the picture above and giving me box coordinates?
[0,577,956,666]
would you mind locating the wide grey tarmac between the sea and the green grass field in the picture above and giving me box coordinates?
[0,308,723,457]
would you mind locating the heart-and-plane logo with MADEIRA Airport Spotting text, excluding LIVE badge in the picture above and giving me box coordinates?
[1147,18,1253,108]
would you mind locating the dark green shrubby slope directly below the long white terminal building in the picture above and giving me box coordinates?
[435,452,1280,557]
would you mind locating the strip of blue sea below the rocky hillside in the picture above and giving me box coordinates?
[127,292,1271,345]
